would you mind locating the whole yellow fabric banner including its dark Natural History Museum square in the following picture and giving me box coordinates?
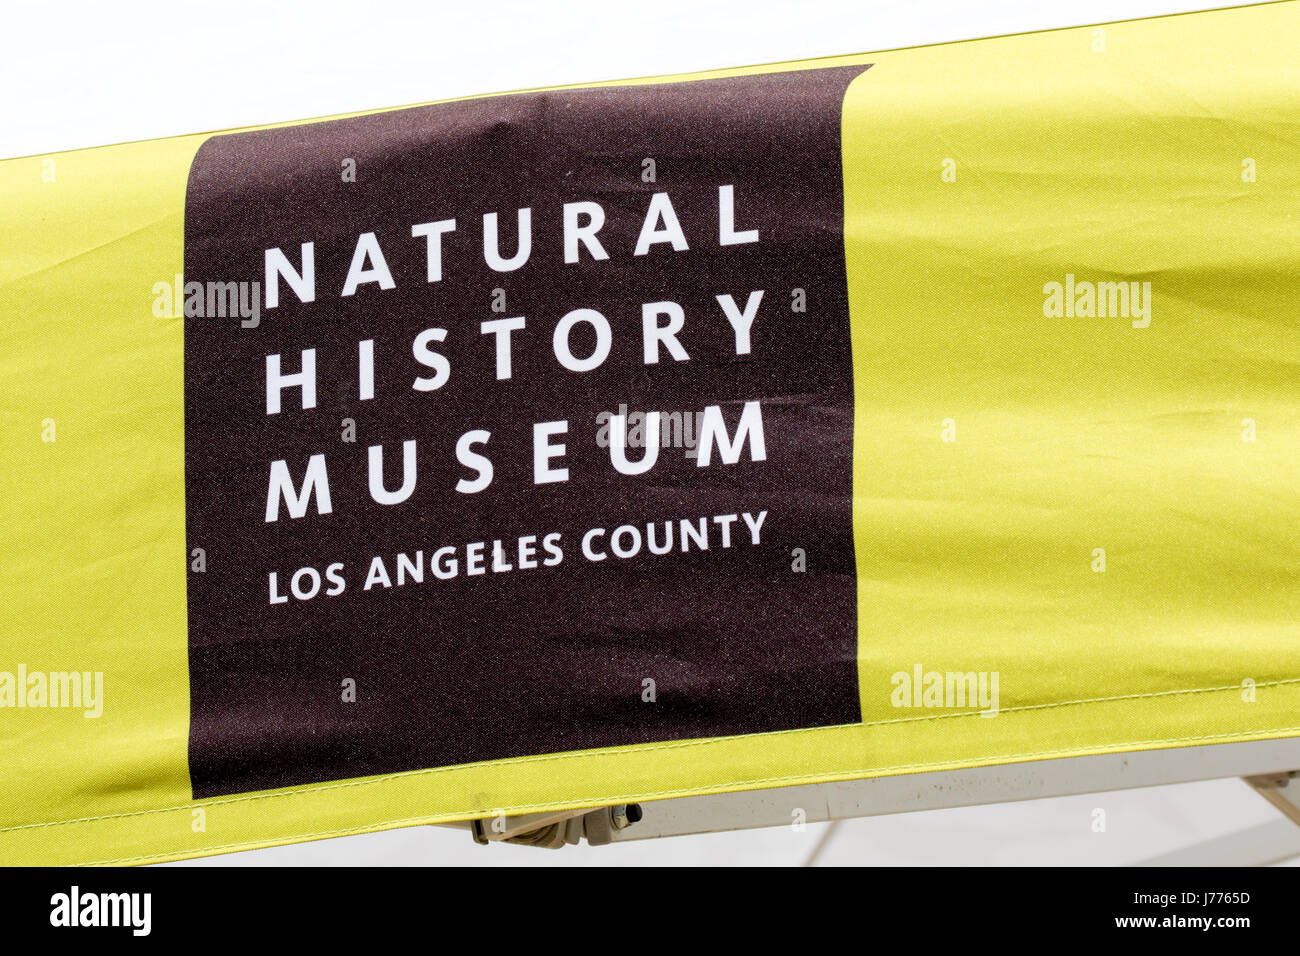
[0,3,1300,864]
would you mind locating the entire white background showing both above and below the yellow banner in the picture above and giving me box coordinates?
[0,0,1278,865]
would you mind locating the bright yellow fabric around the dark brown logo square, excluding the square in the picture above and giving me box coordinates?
[0,3,1300,864]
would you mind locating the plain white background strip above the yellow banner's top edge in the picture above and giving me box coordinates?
[0,0,1263,157]
